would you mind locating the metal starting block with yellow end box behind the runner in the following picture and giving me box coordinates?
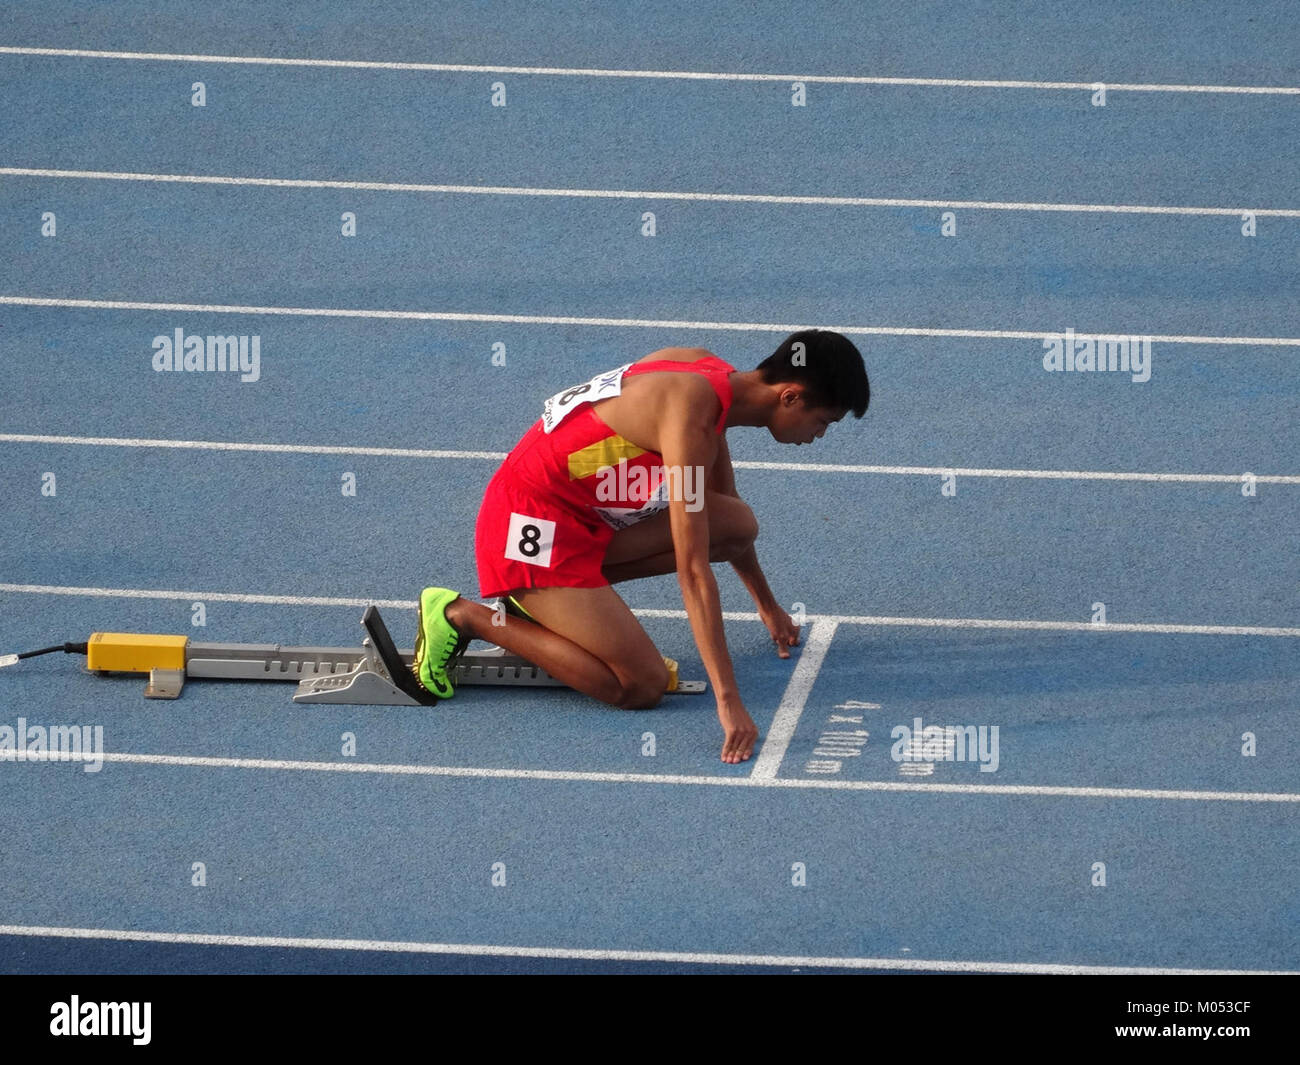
[86,606,707,706]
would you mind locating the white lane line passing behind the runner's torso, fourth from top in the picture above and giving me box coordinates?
[0,433,1300,485]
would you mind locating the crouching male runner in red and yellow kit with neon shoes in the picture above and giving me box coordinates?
[412,330,870,762]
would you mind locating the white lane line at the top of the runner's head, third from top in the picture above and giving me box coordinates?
[0,295,1300,347]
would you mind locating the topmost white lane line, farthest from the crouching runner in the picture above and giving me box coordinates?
[0,46,1300,96]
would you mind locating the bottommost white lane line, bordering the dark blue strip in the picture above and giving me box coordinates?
[0,925,1287,977]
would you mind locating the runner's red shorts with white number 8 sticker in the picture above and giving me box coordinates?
[475,467,614,599]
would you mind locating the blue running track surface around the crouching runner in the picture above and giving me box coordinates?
[0,3,1300,973]
